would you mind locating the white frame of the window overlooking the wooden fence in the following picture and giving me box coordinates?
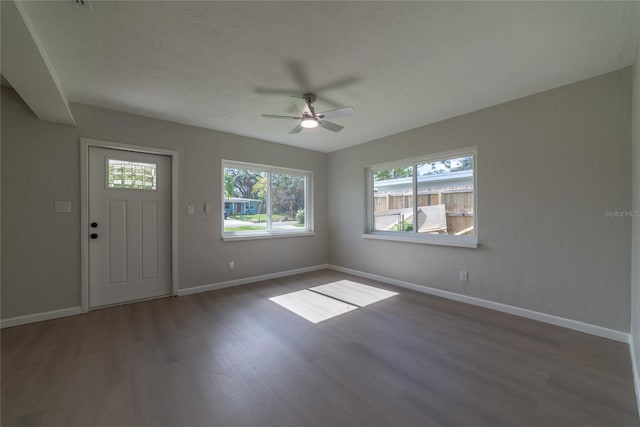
[362,147,478,248]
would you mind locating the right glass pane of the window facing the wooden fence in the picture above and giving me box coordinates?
[416,156,475,236]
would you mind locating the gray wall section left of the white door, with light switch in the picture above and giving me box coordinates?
[1,87,80,318]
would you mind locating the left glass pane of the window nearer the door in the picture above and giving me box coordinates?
[223,168,267,233]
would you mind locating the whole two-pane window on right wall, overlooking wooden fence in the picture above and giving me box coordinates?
[363,148,477,247]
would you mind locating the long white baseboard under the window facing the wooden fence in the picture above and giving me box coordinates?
[328,264,630,343]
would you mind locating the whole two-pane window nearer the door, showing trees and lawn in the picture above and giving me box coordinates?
[222,160,313,239]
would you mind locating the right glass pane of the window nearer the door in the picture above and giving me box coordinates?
[271,173,306,231]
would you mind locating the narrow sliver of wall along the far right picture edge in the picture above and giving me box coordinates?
[631,40,640,392]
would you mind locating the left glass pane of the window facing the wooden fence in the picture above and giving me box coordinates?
[372,165,413,232]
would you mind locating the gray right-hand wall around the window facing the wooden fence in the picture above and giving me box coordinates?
[329,68,631,331]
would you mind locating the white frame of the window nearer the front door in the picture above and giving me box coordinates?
[220,159,315,241]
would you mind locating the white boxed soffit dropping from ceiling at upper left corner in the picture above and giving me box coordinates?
[0,0,75,125]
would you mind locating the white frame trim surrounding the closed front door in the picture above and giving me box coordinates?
[80,137,178,313]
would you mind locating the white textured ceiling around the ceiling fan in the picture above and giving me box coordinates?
[13,1,640,152]
